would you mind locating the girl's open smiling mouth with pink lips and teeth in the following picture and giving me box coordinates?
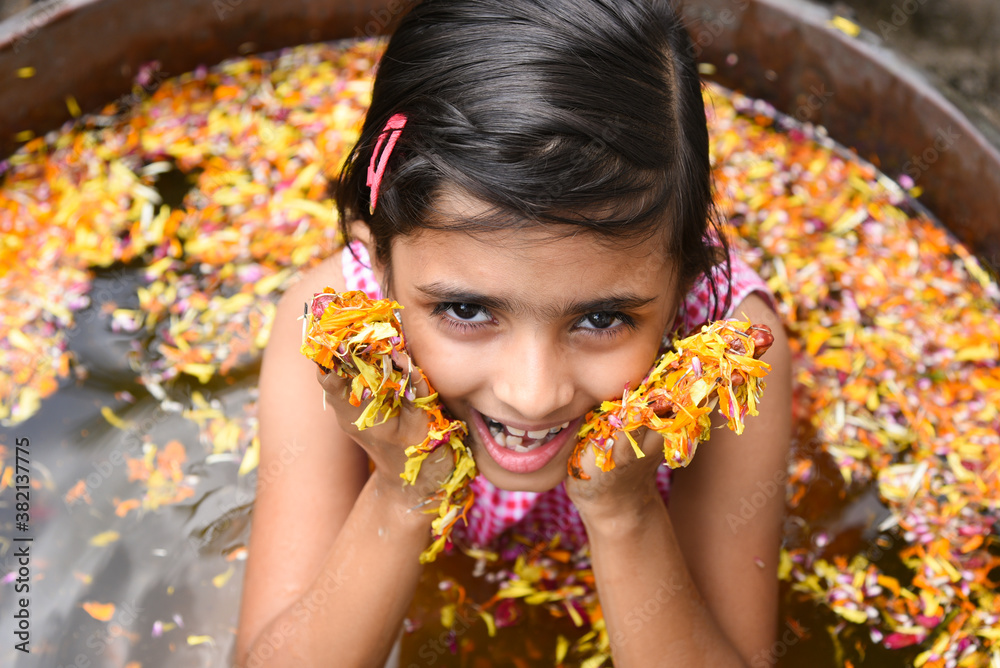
[472,409,583,473]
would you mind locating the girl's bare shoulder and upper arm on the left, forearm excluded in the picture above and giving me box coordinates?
[237,245,368,656]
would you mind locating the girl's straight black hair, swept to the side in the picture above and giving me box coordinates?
[336,0,731,318]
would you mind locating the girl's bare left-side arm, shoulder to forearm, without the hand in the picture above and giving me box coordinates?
[236,256,431,667]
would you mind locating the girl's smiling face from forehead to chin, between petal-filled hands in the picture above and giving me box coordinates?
[376,200,677,492]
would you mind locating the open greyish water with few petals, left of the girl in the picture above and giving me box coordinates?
[0,278,257,668]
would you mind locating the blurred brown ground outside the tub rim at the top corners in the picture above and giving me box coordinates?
[0,0,1000,147]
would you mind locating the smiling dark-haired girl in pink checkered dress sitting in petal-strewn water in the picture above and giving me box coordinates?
[237,0,791,667]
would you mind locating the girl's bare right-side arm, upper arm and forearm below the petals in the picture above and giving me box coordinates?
[578,296,791,668]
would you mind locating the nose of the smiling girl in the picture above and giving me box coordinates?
[493,332,574,421]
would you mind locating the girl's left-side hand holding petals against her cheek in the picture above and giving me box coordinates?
[316,353,454,525]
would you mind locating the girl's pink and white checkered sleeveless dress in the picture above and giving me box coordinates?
[342,241,774,549]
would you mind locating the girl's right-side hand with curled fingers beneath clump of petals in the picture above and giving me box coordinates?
[566,427,663,520]
